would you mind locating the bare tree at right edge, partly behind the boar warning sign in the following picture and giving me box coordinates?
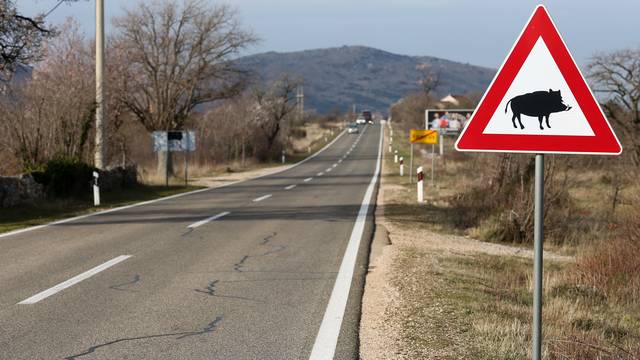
[587,49,640,165]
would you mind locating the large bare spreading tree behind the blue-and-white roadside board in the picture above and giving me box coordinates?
[114,0,256,177]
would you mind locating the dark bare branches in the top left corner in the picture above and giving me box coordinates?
[0,0,54,80]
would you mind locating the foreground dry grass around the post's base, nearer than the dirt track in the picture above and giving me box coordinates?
[393,248,640,359]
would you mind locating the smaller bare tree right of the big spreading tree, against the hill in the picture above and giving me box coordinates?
[253,74,302,157]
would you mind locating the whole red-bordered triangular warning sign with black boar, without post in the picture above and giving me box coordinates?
[456,5,622,154]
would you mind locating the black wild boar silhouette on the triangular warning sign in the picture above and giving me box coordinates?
[504,89,571,130]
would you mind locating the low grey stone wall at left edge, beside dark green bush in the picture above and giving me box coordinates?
[0,175,44,208]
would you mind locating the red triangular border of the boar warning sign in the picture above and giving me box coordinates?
[455,5,622,155]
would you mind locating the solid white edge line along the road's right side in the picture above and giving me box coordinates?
[309,127,382,360]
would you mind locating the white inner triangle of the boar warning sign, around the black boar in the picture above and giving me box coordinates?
[483,38,594,136]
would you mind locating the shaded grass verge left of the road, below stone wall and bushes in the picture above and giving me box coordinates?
[0,185,201,233]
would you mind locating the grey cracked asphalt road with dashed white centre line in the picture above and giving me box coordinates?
[0,124,381,359]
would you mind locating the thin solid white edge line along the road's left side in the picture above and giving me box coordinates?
[0,130,346,238]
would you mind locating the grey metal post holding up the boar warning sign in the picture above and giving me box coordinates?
[532,154,544,360]
